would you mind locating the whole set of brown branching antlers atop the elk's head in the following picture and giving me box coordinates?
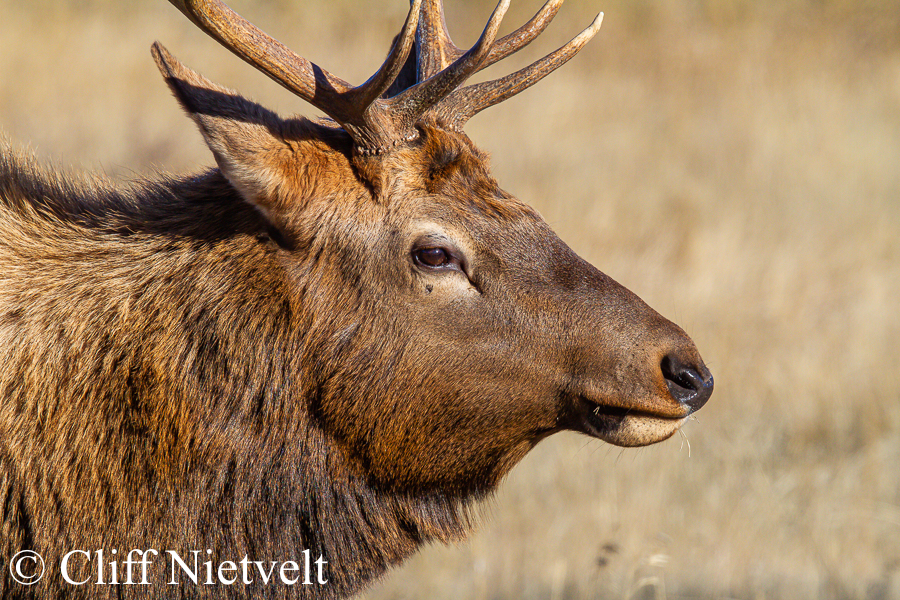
[169,0,602,155]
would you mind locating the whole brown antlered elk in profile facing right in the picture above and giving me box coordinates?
[0,0,713,599]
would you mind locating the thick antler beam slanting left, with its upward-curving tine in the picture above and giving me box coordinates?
[169,0,421,153]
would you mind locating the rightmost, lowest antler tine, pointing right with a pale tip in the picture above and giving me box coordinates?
[432,13,603,130]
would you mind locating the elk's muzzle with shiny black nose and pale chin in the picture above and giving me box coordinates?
[552,265,713,446]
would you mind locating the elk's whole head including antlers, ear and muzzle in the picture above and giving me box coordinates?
[153,0,713,493]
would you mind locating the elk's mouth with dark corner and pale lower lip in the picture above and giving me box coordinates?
[574,396,688,447]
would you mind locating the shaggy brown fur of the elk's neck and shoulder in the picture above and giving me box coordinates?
[0,150,473,597]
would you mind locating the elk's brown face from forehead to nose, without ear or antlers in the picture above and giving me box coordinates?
[292,128,712,489]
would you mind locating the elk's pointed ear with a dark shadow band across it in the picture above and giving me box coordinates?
[151,42,292,216]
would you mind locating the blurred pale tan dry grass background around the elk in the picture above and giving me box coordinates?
[0,0,900,600]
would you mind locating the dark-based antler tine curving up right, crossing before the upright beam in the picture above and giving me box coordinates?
[385,0,510,125]
